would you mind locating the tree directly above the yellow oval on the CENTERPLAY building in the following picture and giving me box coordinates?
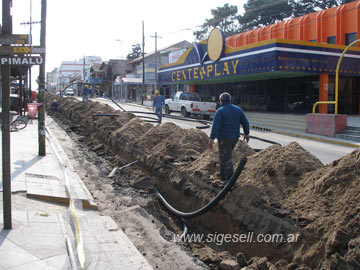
[193,4,239,40]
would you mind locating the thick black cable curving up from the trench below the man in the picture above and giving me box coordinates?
[154,157,247,218]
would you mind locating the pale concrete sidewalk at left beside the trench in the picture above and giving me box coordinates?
[0,120,152,270]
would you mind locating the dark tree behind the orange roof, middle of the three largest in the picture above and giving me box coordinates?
[239,0,293,31]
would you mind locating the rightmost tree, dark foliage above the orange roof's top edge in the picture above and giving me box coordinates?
[292,0,355,17]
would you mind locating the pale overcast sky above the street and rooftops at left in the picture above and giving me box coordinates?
[4,0,246,72]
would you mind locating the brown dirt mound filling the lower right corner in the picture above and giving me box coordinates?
[284,150,360,269]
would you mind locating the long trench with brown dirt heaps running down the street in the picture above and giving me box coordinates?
[47,96,360,269]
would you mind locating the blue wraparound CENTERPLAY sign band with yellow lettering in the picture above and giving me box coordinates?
[159,39,360,83]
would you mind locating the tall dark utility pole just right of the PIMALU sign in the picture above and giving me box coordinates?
[38,0,46,156]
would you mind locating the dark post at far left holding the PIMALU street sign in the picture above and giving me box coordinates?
[1,0,12,230]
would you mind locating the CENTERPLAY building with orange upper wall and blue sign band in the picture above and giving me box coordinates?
[159,1,360,114]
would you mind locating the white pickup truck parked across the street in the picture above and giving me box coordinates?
[165,92,216,119]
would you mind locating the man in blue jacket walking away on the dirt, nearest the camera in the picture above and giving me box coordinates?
[209,92,249,184]
